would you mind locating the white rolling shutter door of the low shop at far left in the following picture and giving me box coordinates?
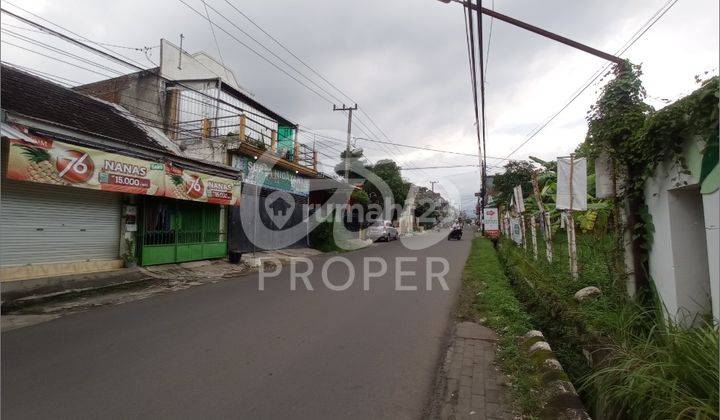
[0,178,121,266]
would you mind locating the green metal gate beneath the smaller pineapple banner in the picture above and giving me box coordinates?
[139,197,227,265]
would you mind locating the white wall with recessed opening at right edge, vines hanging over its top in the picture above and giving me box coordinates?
[645,143,720,325]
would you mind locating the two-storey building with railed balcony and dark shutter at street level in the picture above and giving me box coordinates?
[75,40,318,253]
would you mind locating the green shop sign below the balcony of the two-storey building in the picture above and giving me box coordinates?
[233,155,310,196]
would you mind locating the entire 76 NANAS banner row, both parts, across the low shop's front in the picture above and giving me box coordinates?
[7,126,241,205]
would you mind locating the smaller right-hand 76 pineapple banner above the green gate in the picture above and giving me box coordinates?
[164,164,241,206]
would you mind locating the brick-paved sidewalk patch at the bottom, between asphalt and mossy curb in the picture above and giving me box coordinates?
[440,322,513,420]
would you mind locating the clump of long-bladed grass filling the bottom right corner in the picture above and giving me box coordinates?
[582,311,720,420]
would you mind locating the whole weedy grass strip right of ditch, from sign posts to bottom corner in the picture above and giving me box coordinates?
[500,230,718,419]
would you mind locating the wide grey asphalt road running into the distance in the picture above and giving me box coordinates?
[1,231,470,420]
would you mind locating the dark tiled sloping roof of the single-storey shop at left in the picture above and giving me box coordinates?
[0,65,172,153]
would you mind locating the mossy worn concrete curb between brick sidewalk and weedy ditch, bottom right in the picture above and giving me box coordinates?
[520,330,591,420]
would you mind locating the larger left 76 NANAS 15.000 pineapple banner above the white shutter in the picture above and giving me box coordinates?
[7,135,165,195]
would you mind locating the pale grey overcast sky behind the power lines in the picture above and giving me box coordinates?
[2,0,720,210]
